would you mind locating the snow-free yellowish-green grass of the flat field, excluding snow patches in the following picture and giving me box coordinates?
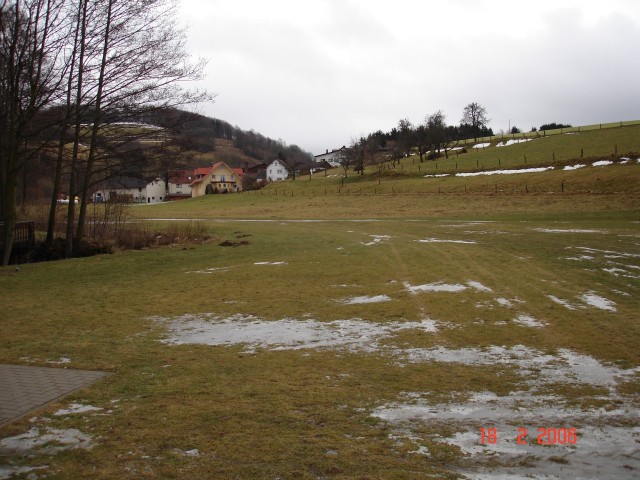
[0,207,640,478]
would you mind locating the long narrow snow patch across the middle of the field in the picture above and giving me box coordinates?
[153,314,438,352]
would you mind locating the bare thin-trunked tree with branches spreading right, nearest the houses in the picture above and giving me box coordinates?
[50,0,213,256]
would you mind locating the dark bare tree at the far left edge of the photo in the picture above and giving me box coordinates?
[0,0,66,265]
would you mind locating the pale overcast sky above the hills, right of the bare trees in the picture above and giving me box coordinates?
[180,0,640,155]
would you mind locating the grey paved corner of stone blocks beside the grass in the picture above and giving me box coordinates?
[0,364,108,426]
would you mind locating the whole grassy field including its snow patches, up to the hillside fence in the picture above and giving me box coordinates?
[0,131,640,479]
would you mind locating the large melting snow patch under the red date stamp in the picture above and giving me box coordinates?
[371,345,640,479]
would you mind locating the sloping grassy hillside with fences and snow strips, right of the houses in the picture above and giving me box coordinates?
[268,124,640,194]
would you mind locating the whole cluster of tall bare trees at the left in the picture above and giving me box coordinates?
[0,0,212,265]
